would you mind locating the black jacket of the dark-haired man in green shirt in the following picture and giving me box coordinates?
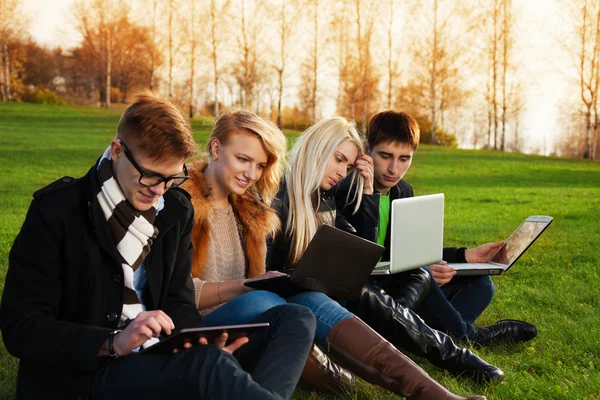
[335,178,467,263]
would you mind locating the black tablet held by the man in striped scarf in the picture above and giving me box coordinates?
[140,322,269,354]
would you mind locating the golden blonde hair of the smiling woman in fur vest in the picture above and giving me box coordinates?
[206,108,286,205]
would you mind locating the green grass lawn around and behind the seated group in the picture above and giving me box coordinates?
[0,104,600,400]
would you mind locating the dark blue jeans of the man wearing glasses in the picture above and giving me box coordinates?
[92,304,315,400]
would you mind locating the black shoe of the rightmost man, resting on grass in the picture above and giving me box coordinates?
[471,319,537,346]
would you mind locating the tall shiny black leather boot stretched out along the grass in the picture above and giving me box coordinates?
[349,283,504,383]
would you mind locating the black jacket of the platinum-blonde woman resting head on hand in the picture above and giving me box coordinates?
[267,180,379,271]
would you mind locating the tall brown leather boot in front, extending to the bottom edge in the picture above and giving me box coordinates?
[327,317,485,400]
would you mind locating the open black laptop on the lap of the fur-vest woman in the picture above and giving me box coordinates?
[245,225,384,300]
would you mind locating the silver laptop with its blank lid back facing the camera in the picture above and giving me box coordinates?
[371,193,444,275]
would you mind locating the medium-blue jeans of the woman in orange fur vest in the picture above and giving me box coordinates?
[203,290,354,344]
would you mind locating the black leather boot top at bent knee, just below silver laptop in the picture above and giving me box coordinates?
[371,268,431,310]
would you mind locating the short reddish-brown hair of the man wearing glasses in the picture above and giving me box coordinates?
[117,91,198,161]
